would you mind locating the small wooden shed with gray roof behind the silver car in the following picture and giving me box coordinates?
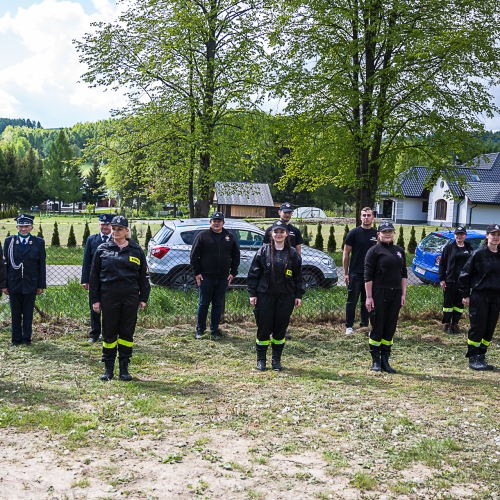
[212,182,279,219]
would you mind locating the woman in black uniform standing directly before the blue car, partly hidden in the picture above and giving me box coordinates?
[438,226,472,335]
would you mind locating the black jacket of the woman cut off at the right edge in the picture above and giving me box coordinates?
[458,245,500,297]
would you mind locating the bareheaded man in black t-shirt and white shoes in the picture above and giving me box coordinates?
[342,207,377,335]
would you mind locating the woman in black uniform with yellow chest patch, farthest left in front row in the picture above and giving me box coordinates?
[89,215,150,381]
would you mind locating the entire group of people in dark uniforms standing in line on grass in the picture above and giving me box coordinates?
[0,206,500,381]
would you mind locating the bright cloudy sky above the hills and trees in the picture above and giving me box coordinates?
[0,0,500,130]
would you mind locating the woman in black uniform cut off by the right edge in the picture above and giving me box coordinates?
[458,224,500,371]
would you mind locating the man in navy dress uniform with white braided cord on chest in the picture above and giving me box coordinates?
[2,214,47,347]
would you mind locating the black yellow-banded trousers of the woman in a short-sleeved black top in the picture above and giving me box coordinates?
[369,288,403,352]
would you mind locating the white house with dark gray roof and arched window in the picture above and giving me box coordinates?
[375,153,500,229]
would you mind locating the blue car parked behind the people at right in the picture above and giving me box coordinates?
[411,230,486,284]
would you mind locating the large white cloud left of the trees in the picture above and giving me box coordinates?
[0,0,123,125]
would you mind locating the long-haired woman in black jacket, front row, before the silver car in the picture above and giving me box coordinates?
[247,220,305,371]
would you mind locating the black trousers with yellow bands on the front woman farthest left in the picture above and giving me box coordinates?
[101,290,139,361]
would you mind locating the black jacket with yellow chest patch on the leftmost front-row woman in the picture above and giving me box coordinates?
[89,239,151,304]
